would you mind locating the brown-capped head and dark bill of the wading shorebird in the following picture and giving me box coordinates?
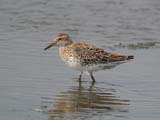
[44,33,73,50]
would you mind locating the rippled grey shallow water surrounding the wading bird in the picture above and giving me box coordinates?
[0,0,160,120]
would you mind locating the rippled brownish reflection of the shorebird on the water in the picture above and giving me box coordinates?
[41,82,129,120]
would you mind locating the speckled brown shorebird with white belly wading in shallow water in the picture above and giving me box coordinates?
[44,33,134,82]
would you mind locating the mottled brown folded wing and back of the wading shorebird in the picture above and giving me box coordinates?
[71,43,127,65]
